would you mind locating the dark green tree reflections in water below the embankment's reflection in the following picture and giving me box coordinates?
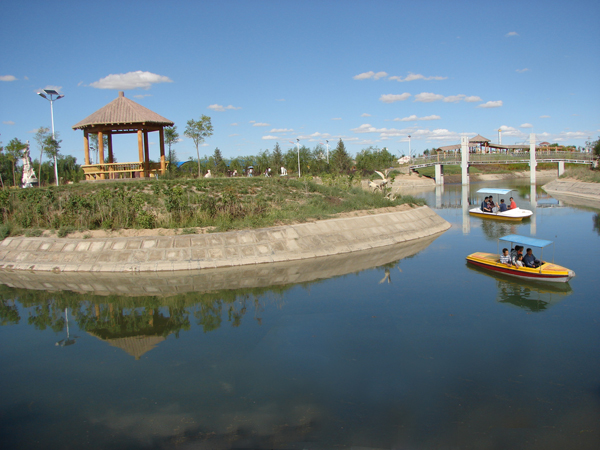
[0,285,291,340]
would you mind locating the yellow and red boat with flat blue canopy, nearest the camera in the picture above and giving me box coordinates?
[467,234,575,283]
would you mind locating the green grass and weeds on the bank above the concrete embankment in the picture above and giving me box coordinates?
[0,175,425,239]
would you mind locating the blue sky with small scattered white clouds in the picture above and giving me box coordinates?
[0,0,600,163]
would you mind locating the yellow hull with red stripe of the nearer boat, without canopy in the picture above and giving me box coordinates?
[467,252,575,283]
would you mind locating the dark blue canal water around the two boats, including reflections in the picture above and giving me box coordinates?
[0,182,600,449]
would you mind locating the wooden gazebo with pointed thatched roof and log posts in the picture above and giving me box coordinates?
[73,91,174,180]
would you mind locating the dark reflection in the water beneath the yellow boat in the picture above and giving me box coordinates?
[467,264,573,312]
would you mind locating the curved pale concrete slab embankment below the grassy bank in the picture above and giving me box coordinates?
[0,206,450,272]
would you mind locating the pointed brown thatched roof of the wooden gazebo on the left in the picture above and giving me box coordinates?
[73,91,175,130]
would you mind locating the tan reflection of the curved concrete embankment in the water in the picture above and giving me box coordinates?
[0,233,440,297]
